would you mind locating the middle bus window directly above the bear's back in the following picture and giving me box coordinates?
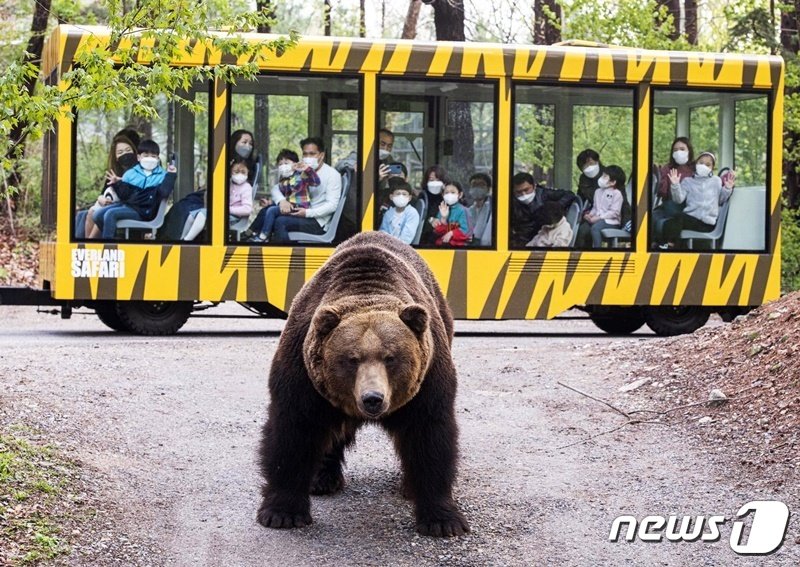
[375,79,497,247]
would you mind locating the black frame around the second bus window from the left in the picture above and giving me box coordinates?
[223,69,366,248]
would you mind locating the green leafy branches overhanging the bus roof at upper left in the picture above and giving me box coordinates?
[0,0,298,189]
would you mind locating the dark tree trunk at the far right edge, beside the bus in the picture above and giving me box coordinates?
[781,0,800,208]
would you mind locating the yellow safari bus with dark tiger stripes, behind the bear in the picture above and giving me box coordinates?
[18,26,784,335]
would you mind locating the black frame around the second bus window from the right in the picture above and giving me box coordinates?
[507,81,640,254]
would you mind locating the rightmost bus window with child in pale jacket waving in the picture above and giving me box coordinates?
[650,90,769,251]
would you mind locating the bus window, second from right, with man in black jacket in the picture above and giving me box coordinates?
[509,84,635,249]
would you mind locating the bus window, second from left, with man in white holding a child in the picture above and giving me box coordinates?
[229,75,361,244]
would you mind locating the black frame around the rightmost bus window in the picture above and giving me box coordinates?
[647,85,777,255]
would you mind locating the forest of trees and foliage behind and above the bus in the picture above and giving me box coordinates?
[0,0,800,291]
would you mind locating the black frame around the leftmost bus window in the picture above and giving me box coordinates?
[69,79,214,246]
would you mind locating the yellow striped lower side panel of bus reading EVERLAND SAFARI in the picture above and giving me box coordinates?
[55,244,779,319]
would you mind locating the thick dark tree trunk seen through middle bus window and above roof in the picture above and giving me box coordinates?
[433,0,475,181]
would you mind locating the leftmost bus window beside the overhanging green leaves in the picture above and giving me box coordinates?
[73,82,210,241]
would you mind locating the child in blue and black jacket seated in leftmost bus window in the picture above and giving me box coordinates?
[90,140,178,240]
